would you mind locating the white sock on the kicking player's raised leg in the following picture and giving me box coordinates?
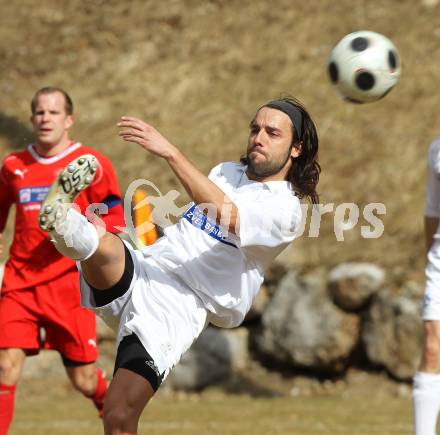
[50,208,99,261]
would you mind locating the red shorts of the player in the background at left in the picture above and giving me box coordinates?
[0,271,98,363]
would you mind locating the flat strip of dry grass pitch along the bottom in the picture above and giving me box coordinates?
[10,377,412,435]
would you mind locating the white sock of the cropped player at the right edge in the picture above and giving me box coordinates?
[413,372,440,435]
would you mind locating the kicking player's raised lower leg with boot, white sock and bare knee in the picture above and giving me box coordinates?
[39,154,125,289]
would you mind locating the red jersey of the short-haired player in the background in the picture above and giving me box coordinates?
[0,143,125,292]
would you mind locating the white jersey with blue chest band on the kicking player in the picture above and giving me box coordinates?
[142,162,301,327]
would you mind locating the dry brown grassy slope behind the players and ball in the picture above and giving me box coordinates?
[0,0,440,279]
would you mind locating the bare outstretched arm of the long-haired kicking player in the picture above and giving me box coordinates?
[118,116,239,233]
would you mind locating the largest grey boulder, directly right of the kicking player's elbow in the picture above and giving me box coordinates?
[252,272,360,373]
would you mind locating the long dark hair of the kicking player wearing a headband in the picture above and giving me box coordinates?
[240,97,321,204]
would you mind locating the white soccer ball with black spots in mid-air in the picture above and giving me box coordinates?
[328,30,401,103]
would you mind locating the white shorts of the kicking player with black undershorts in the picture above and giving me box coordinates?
[79,243,208,379]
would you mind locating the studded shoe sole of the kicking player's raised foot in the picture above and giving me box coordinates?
[38,154,98,231]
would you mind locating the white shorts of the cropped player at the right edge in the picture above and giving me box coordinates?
[422,240,440,320]
